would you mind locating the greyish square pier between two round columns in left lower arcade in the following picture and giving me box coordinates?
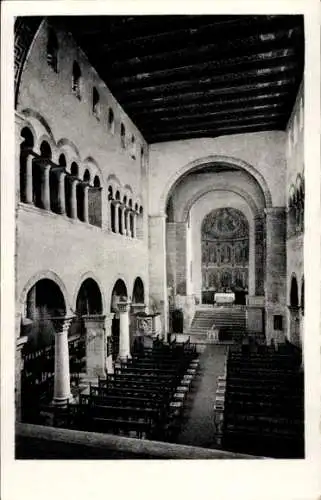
[83,314,107,378]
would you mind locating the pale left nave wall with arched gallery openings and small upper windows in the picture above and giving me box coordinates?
[16,21,149,324]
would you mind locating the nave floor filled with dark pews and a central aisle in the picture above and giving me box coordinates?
[16,330,304,458]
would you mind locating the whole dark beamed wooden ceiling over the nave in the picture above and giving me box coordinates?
[56,15,304,143]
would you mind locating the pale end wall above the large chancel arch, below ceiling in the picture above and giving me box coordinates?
[149,131,286,214]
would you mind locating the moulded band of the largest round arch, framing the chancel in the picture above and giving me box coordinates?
[159,155,272,213]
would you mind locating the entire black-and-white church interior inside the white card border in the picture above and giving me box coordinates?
[14,15,305,459]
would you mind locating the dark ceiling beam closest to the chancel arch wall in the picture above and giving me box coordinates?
[148,120,281,144]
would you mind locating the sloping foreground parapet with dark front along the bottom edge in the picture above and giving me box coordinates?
[16,423,263,459]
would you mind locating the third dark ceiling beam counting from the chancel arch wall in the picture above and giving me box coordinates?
[142,101,285,127]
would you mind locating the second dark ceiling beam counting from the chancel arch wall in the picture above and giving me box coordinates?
[143,112,285,133]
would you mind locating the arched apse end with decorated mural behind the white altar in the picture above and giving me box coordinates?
[201,207,249,304]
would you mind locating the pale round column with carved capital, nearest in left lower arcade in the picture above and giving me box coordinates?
[50,317,73,406]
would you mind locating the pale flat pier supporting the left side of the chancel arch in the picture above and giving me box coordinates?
[148,214,168,338]
